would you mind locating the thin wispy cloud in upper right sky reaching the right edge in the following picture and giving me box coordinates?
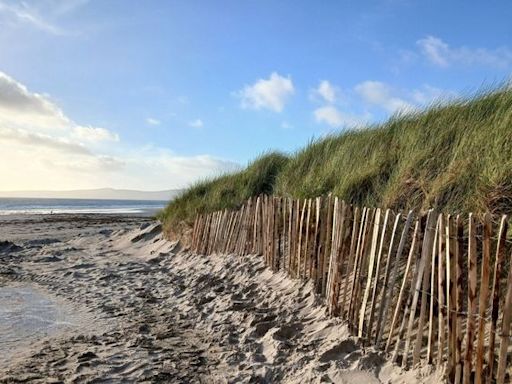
[416,36,512,68]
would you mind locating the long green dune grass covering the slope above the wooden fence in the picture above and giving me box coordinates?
[160,86,512,230]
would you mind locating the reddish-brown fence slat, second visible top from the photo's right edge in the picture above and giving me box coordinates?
[475,214,492,384]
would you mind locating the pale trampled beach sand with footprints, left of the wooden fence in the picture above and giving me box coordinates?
[0,215,441,383]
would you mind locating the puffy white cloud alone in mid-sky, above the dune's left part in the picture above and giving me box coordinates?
[236,72,295,112]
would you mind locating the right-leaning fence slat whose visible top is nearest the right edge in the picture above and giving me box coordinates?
[487,215,508,382]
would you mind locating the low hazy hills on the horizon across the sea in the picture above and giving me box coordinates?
[0,188,181,200]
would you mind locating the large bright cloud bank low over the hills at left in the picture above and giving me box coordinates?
[0,72,238,190]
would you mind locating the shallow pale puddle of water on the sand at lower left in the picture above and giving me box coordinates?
[0,285,78,363]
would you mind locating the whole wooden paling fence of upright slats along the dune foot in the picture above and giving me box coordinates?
[191,195,512,383]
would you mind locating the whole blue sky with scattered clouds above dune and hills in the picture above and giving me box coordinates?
[0,0,512,191]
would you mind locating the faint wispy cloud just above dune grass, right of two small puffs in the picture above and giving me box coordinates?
[354,80,416,113]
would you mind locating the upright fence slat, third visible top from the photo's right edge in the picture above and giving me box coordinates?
[463,213,477,384]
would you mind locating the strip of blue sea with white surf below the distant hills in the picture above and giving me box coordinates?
[0,198,167,216]
